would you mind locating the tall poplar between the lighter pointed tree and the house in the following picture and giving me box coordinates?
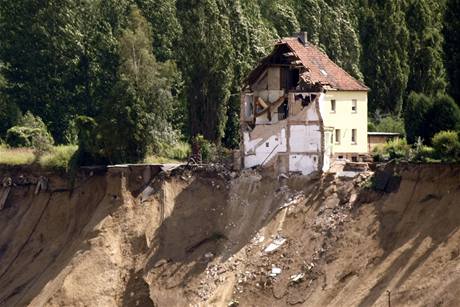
[177,0,234,143]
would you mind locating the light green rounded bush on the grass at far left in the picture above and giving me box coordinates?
[6,112,54,152]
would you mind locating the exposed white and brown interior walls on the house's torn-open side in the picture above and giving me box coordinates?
[243,90,328,175]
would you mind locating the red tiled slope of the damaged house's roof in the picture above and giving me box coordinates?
[278,37,369,91]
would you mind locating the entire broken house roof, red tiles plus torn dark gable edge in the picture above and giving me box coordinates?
[245,37,369,91]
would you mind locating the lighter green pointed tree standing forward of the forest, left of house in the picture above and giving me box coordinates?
[97,8,178,163]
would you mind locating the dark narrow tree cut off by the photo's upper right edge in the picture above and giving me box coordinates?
[443,0,460,103]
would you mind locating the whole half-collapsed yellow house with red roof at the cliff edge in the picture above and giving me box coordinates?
[241,32,368,175]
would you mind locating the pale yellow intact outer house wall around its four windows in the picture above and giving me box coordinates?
[321,91,368,154]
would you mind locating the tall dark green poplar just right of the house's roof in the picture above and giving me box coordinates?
[360,0,409,115]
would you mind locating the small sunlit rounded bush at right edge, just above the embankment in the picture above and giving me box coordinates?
[431,131,460,162]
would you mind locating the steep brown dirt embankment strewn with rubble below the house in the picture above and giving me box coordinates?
[0,165,460,306]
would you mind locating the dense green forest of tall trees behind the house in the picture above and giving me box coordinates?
[0,0,460,163]
